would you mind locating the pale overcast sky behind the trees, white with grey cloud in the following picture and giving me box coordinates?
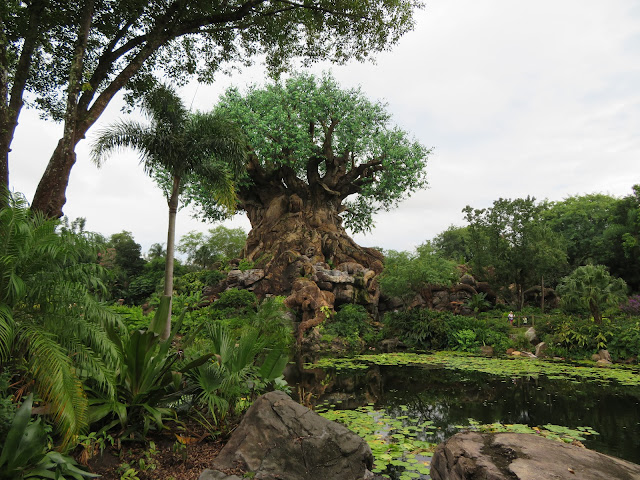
[10,0,640,255]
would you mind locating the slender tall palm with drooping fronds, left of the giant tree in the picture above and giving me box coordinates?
[91,85,246,339]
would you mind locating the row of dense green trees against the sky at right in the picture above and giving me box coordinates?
[430,185,640,304]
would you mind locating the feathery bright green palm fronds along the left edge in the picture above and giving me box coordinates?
[0,190,119,445]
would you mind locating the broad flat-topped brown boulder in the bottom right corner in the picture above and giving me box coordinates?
[431,432,640,480]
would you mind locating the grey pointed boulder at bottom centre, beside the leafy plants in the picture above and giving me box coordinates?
[199,392,373,480]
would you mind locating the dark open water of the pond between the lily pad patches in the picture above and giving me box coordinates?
[288,366,640,463]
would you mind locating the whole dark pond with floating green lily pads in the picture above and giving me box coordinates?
[289,356,640,479]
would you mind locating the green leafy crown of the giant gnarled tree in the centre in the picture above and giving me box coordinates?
[210,74,430,232]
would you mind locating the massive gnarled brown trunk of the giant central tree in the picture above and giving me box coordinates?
[240,185,384,342]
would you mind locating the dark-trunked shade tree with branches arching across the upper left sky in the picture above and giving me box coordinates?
[0,0,421,216]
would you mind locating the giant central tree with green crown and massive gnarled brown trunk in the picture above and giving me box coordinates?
[200,74,429,300]
